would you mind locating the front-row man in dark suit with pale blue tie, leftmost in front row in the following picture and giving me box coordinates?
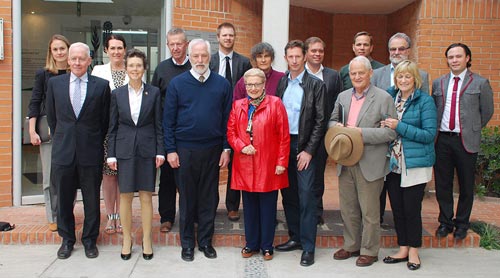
[46,43,110,259]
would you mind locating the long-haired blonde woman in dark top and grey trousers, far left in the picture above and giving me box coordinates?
[28,34,69,232]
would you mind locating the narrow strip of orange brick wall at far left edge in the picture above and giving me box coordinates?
[0,0,13,207]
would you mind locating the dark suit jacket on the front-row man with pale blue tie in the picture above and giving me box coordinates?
[46,73,110,166]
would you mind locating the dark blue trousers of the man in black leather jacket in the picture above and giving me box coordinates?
[281,135,318,252]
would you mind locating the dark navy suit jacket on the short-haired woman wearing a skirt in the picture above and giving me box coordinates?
[108,84,165,159]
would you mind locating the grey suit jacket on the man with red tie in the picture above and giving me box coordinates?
[432,70,494,153]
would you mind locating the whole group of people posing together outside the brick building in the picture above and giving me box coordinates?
[29,22,493,270]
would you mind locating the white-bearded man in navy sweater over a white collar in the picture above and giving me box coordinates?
[163,39,232,261]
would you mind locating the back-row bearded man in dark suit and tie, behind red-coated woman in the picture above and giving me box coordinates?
[210,22,252,221]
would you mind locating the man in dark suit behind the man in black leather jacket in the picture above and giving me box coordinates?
[304,37,342,224]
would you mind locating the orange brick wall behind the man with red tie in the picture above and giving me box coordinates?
[414,0,500,126]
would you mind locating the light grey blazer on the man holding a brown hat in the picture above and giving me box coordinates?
[329,85,397,181]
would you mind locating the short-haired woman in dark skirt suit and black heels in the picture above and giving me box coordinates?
[107,49,165,260]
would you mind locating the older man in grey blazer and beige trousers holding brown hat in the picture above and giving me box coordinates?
[329,56,397,266]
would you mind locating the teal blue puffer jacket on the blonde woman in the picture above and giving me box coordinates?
[387,87,437,169]
